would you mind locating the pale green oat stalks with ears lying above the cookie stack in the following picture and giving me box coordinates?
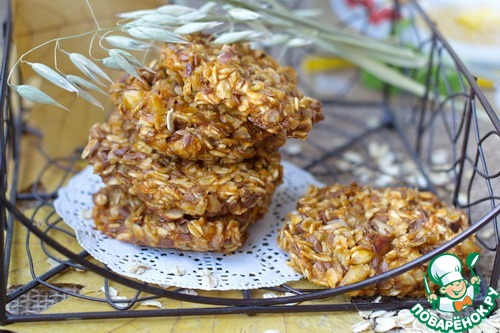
[8,0,426,108]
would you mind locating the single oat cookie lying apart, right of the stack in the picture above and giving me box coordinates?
[278,184,479,297]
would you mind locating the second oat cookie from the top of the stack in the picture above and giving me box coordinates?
[111,73,285,164]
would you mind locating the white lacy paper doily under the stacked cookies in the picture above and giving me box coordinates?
[54,162,321,290]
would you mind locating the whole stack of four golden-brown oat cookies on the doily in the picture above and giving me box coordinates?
[82,36,323,252]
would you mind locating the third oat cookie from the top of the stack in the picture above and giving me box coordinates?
[82,112,282,218]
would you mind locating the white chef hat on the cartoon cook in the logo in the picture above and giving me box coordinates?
[427,253,464,287]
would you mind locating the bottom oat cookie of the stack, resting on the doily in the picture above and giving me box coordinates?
[92,186,271,253]
